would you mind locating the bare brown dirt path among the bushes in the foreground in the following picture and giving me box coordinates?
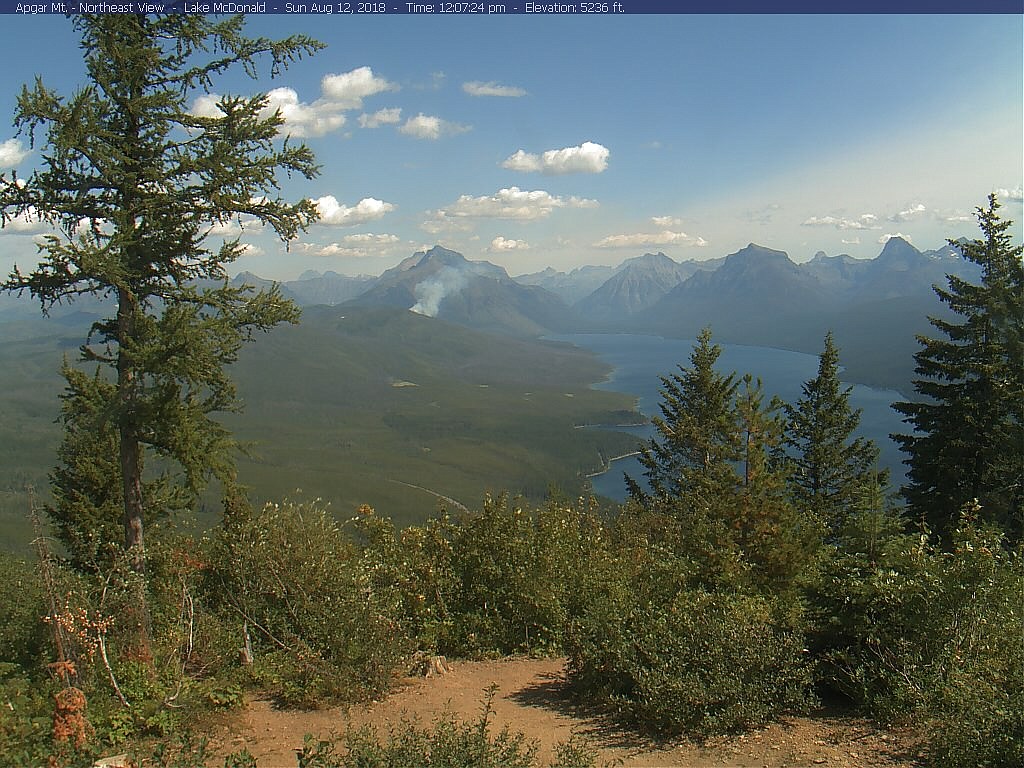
[209,658,914,768]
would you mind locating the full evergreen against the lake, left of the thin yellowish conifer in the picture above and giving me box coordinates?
[626,329,741,506]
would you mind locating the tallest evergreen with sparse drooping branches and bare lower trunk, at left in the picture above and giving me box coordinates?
[0,13,322,657]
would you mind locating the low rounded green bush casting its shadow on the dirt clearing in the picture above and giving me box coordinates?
[569,590,810,737]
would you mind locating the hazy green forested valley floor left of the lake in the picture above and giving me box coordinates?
[0,306,638,549]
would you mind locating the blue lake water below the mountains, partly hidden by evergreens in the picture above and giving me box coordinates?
[548,334,906,501]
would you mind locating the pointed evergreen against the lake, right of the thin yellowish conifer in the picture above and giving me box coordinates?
[784,332,888,536]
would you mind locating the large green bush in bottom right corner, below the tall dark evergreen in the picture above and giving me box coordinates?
[812,510,1024,768]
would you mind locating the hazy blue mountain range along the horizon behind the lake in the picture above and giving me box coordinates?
[0,238,979,391]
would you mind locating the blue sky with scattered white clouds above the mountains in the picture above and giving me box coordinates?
[0,15,1024,280]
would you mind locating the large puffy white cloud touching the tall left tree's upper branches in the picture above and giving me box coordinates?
[190,67,397,137]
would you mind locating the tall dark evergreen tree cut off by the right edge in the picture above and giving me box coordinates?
[893,195,1024,542]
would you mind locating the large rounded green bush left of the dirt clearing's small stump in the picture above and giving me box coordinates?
[207,502,412,707]
